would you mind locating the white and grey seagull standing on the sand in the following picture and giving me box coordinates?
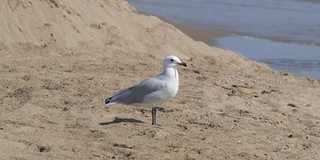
[104,55,187,125]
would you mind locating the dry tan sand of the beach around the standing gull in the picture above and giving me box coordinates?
[0,0,320,160]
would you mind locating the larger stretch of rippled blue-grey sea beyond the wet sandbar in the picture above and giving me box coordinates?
[128,0,320,46]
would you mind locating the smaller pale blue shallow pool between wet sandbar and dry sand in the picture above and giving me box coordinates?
[215,36,320,79]
